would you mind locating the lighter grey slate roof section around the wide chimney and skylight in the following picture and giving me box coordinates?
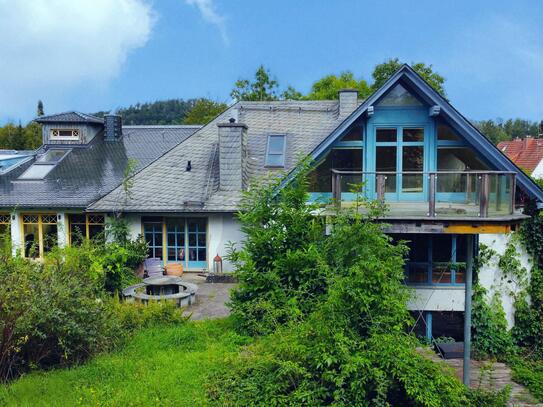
[89,101,343,212]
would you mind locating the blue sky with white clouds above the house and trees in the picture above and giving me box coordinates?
[0,0,543,124]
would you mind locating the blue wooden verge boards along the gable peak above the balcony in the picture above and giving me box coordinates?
[304,64,543,202]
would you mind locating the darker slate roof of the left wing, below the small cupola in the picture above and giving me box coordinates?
[0,126,200,208]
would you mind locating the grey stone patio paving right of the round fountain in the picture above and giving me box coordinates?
[182,273,236,319]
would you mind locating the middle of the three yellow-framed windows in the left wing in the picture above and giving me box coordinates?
[23,214,58,258]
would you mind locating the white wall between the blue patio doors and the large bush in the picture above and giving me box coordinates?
[207,213,244,272]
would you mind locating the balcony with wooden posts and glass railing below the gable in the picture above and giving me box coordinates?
[332,169,524,220]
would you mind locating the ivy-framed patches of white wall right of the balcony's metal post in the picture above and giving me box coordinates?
[478,234,531,328]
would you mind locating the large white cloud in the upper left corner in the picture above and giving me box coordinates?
[0,0,154,118]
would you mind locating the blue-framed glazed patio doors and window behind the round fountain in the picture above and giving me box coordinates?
[142,217,207,268]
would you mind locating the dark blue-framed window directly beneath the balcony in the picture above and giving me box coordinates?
[393,234,467,285]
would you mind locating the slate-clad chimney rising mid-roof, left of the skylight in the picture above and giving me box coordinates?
[217,118,247,191]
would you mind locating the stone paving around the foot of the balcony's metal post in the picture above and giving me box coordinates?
[421,350,543,407]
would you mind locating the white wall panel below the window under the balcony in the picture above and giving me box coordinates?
[407,287,465,312]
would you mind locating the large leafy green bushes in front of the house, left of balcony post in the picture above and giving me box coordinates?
[217,171,492,406]
